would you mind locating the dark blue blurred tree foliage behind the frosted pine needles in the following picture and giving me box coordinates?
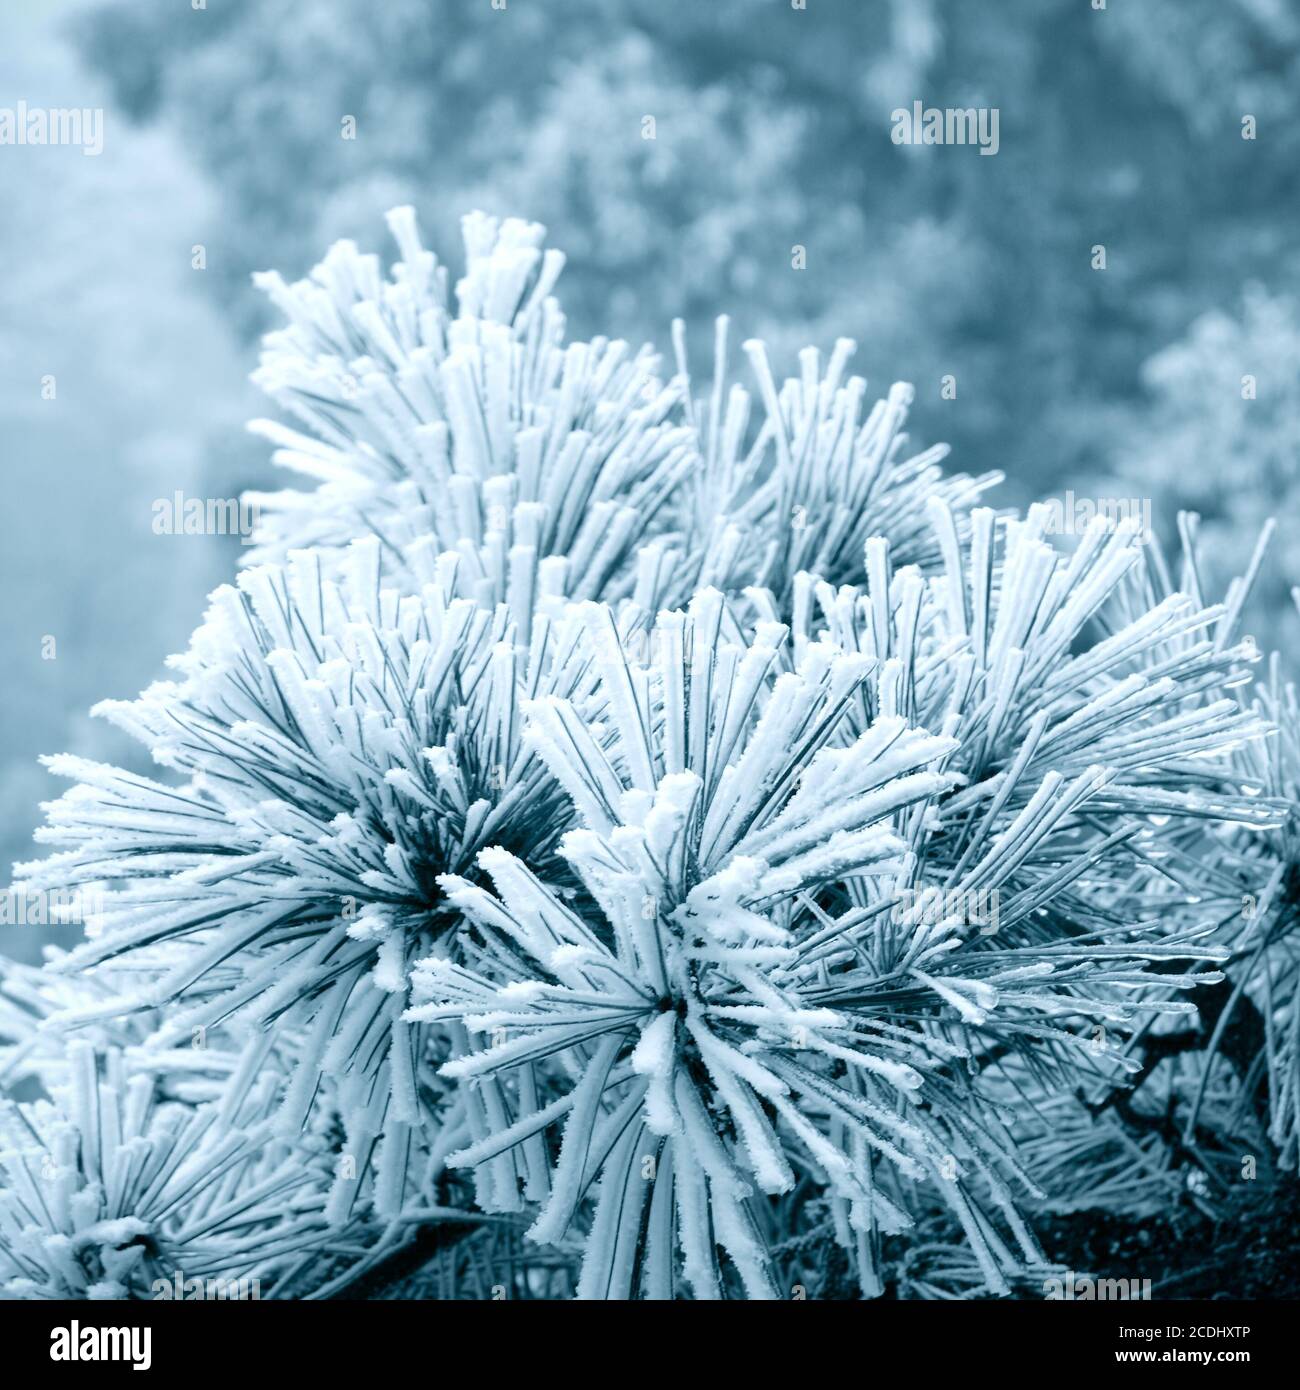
[81,0,1300,619]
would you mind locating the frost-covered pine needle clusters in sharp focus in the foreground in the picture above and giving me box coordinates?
[0,209,1300,1300]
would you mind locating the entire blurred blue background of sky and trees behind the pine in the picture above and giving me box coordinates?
[0,0,1300,958]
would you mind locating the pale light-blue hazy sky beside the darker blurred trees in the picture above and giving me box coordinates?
[0,6,260,960]
